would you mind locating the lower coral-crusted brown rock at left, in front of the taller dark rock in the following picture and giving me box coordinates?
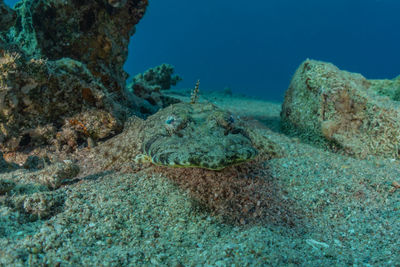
[0,51,130,151]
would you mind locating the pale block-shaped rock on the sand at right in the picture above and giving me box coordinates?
[281,60,400,158]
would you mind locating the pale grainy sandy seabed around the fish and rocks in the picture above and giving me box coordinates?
[0,93,400,266]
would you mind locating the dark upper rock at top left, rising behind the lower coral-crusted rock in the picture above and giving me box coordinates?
[8,0,148,91]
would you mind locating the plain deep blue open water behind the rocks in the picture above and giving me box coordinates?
[5,0,400,101]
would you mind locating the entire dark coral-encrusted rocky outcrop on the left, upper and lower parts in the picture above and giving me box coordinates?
[0,0,147,152]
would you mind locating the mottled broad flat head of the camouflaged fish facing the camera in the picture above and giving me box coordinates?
[142,103,258,170]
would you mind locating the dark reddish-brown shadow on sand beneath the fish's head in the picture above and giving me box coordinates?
[148,161,304,228]
